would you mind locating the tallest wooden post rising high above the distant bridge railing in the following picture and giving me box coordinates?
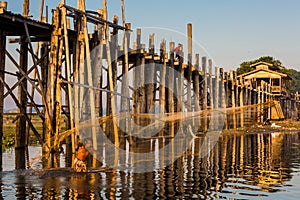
[187,24,193,112]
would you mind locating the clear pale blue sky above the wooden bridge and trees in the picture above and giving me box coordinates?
[4,0,300,70]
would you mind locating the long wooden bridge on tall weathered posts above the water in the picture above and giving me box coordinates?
[0,0,299,169]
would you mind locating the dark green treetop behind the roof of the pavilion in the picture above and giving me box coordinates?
[236,56,284,75]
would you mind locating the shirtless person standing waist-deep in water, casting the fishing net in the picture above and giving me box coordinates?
[74,142,89,172]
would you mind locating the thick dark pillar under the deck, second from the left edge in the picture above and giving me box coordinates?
[15,36,28,169]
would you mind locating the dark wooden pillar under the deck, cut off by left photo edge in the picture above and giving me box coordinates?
[0,30,6,171]
